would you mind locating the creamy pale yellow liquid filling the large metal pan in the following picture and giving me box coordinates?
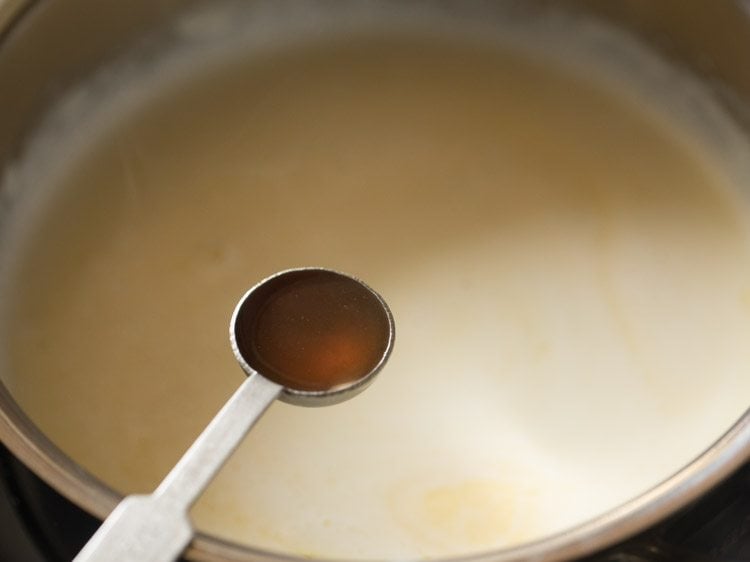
[5,10,750,559]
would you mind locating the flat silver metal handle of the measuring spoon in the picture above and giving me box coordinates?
[75,374,282,562]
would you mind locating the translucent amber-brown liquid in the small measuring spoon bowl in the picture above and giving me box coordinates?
[235,270,391,391]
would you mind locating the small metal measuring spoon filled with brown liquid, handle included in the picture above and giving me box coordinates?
[75,268,395,562]
